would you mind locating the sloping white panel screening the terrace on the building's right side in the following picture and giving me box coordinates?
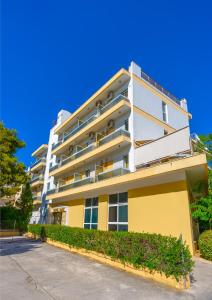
[135,127,191,167]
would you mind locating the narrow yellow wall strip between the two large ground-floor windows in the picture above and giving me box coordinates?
[98,195,108,230]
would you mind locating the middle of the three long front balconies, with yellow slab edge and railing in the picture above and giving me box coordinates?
[50,129,131,176]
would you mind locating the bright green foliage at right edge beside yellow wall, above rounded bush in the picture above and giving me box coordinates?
[191,170,212,232]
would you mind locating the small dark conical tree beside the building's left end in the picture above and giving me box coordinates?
[16,182,33,229]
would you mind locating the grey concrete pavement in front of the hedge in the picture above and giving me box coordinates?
[0,237,212,300]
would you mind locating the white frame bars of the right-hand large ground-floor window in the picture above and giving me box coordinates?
[108,192,128,231]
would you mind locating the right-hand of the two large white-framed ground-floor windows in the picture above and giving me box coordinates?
[108,193,128,231]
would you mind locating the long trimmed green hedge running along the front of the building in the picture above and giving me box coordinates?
[28,224,193,280]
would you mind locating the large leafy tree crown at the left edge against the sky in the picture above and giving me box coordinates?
[0,122,27,197]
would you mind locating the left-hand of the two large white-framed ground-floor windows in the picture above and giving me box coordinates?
[84,198,98,229]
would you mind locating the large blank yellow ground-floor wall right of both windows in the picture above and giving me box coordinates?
[128,181,193,253]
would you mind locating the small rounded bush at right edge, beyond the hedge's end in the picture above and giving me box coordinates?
[199,230,212,261]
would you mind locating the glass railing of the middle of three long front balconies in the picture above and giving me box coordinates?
[50,128,130,172]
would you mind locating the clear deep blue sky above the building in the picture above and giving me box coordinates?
[1,0,212,164]
